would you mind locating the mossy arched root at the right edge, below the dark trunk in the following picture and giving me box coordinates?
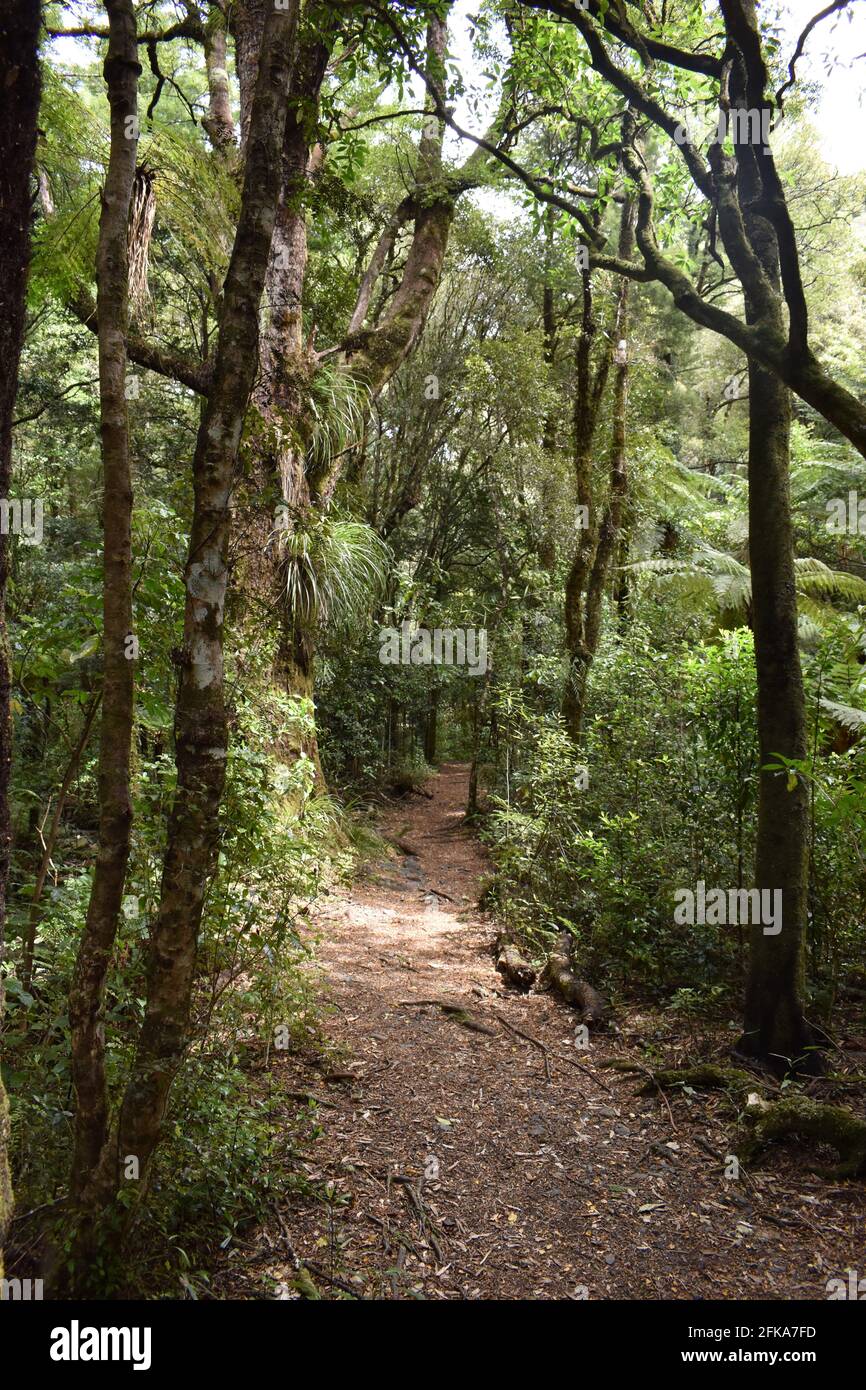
[740,1095,866,1179]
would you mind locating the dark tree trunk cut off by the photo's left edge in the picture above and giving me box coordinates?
[0,0,40,1279]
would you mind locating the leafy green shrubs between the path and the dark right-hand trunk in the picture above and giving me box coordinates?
[489,626,758,995]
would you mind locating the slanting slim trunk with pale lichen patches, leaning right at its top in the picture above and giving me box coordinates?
[111,3,299,1191]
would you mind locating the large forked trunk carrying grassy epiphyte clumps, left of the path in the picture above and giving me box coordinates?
[236,13,455,791]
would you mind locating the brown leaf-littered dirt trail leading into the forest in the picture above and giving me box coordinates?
[272,765,866,1300]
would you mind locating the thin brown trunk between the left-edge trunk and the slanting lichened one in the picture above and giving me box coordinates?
[70,0,142,1205]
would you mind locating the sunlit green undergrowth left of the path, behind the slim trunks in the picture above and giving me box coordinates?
[4,702,353,1295]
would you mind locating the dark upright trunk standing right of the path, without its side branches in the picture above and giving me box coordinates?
[714,35,820,1072]
